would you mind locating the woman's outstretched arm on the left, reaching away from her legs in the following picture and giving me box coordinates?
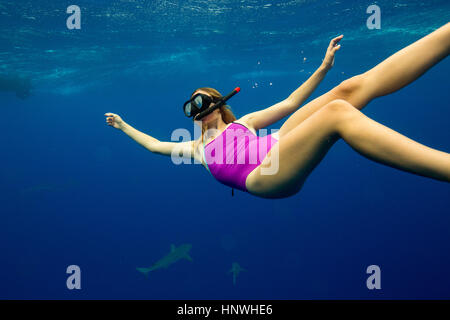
[105,113,194,157]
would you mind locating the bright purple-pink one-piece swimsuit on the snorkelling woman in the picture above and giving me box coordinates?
[204,122,277,191]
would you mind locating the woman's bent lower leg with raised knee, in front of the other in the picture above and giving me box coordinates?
[247,100,450,198]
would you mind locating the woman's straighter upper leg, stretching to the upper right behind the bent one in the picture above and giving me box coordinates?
[279,23,450,137]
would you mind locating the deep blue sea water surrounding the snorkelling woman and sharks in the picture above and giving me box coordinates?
[0,0,450,299]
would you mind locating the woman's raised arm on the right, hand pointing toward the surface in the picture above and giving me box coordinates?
[239,35,343,130]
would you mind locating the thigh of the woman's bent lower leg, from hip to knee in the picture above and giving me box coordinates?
[246,100,344,198]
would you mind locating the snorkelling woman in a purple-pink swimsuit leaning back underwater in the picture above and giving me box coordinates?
[105,23,450,198]
